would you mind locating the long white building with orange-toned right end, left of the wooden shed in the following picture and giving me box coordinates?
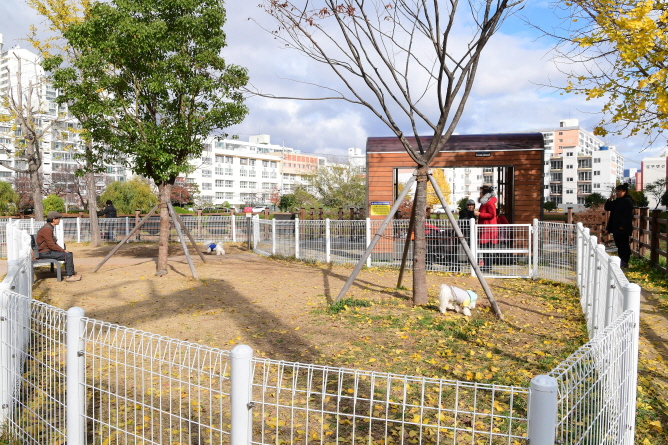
[183,134,326,207]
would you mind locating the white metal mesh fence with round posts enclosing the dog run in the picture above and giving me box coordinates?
[0,220,640,445]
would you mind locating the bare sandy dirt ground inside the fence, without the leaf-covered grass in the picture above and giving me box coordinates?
[35,244,584,362]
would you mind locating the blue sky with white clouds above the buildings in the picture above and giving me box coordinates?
[0,0,656,167]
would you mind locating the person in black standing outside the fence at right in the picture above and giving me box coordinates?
[605,183,635,269]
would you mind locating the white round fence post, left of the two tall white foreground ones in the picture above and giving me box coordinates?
[66,307,86,445]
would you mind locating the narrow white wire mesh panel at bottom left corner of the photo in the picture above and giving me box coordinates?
[0,291,67,444]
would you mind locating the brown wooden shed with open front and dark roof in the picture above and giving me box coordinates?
[366,133,545,224]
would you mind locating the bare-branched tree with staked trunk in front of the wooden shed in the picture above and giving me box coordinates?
[255,0,523,304]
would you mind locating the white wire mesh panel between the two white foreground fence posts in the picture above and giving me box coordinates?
[82,319,230,444]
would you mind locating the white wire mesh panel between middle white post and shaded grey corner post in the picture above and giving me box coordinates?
[252,359,528,444]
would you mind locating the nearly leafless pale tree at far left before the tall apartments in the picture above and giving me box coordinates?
[1,50,59,220]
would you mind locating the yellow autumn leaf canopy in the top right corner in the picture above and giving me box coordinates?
[549,0,668,144]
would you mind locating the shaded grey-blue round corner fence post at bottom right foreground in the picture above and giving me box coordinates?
[527,375,559,445]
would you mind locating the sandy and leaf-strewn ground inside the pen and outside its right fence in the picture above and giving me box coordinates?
[28,245,668,444]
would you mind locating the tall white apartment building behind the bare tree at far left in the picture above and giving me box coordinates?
[0,34,126,207]
